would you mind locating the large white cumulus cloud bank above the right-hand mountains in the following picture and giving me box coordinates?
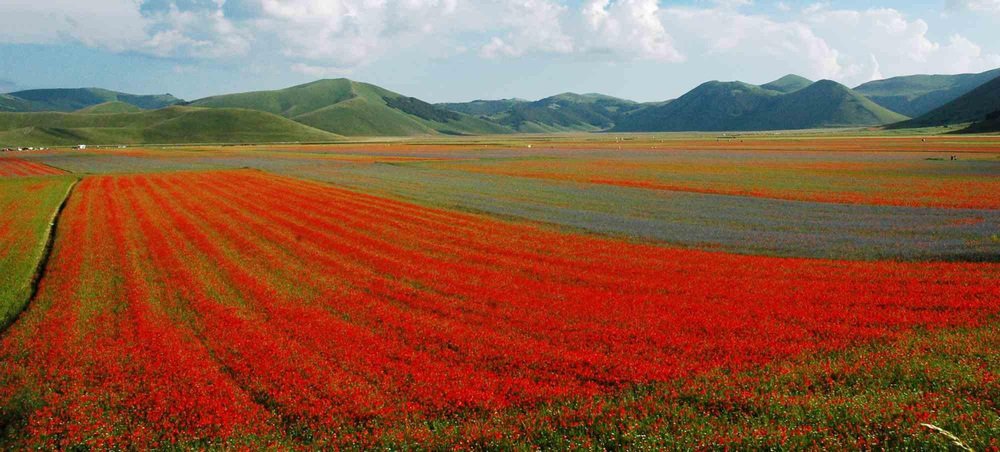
[661,3,1000,85]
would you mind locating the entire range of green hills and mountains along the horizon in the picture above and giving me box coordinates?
[0,69,1000,146]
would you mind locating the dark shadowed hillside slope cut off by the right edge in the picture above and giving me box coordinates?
[890,73,1000,131]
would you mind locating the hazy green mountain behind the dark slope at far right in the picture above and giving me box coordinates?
[854,69,1000,118]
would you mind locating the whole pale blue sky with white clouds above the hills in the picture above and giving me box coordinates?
[0,0,1000,102]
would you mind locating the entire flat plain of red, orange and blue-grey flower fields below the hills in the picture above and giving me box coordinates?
[0,132,1000,449]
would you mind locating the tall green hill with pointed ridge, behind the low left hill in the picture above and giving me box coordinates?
[190,79,511,136]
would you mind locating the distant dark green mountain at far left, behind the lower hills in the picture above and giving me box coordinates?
[0,88,182,112]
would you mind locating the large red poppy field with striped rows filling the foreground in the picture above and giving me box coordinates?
[0,171,1000,447]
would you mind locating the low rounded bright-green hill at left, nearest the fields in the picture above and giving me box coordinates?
[0,106,342,146]
